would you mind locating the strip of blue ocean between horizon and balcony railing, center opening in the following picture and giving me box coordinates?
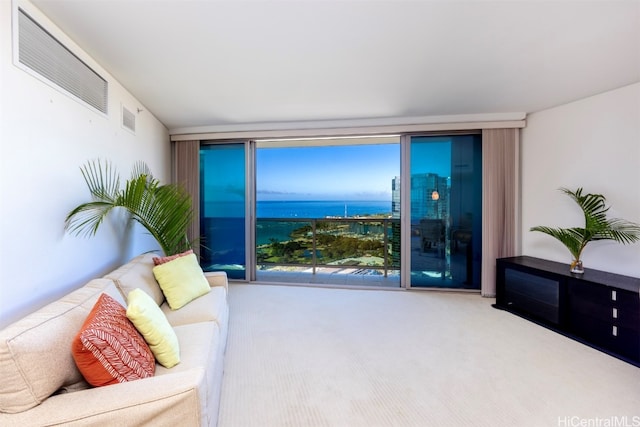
[256,200,391,218]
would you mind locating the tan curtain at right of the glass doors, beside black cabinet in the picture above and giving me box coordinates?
[481,129,519,297]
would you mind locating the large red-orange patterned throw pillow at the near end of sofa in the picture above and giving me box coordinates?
[71,294,156,386]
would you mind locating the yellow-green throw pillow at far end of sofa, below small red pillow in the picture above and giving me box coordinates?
[153,254,211,310]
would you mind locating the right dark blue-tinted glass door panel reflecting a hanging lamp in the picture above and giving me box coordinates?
[410,135,482,289]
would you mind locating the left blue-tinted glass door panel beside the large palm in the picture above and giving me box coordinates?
[200,143,247,279]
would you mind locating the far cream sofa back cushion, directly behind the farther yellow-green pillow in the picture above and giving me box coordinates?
[104,253,164,305]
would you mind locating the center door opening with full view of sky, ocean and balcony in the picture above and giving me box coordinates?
[255,136,400,287]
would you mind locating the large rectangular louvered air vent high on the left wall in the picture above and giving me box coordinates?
[18,9,108,114]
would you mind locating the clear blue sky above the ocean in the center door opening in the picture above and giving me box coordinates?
[256,144,400,201]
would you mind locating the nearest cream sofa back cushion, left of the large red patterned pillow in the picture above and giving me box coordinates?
[0,279,124,413]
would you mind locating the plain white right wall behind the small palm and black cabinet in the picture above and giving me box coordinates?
[521,83,640,277]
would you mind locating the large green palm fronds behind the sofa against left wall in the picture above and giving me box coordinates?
[65,160,193,255]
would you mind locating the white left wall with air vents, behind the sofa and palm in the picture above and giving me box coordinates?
[0,0,170,327]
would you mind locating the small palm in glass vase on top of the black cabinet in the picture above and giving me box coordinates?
[530,188,640,274]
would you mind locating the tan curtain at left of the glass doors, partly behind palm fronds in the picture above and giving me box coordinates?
[173,140,200,256]
